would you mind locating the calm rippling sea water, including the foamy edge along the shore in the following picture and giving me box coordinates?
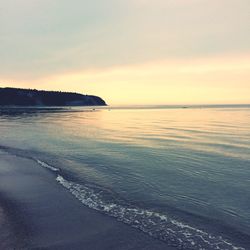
[0,105,250,250]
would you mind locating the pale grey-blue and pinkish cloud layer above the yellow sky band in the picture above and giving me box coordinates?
[0,0,250,80]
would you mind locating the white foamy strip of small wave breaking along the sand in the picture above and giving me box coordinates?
[56,175,245,250]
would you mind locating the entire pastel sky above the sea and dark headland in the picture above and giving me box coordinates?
[0,0,250,105]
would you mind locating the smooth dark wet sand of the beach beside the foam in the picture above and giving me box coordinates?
[0,152,174,250]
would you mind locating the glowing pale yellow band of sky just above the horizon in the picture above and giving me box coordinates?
[2,55,250,105]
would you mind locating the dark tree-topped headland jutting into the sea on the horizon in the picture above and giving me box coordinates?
[0,88,106,106]
